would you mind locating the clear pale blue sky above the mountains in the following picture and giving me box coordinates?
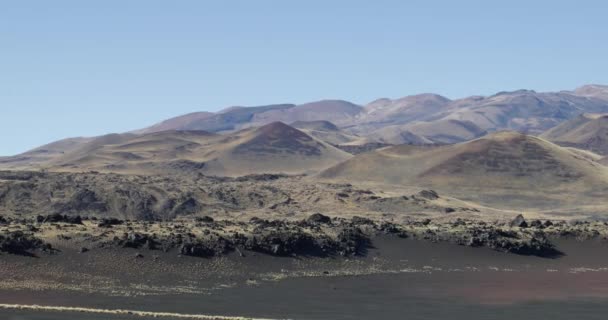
[0,0,608,155]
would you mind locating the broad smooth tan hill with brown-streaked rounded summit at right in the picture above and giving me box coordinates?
[320,132,608,208]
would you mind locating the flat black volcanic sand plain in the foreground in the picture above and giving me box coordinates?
[0,238,608,319]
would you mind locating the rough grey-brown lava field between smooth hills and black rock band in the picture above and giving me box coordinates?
[0,171,492,221]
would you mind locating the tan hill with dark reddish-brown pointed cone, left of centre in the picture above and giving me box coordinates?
[40,122,350,176]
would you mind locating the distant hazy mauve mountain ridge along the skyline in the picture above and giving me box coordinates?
[134,85,608,143]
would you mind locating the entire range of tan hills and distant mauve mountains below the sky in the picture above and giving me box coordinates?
[0,85,608,216]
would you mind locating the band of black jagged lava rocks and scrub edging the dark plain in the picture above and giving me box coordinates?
[0,213,608,258]
